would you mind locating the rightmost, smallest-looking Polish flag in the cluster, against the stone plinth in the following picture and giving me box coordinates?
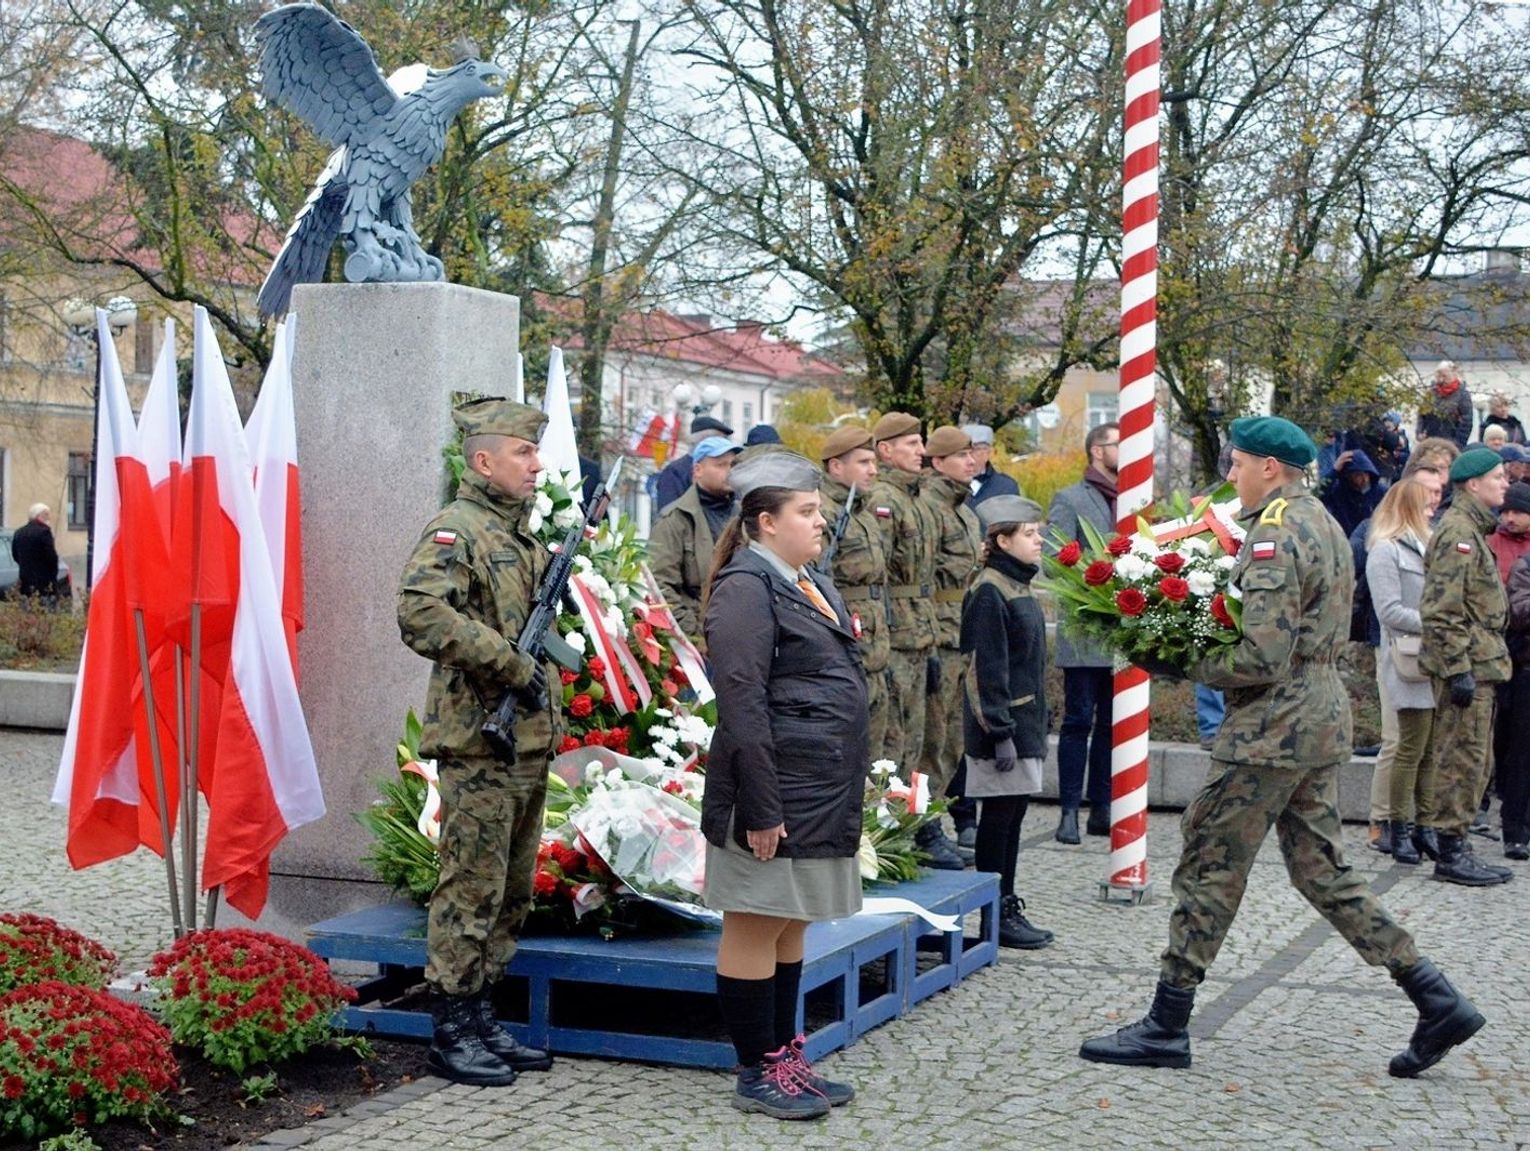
[245,314,303,680]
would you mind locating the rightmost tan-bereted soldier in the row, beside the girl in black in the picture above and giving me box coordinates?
[920,426,982,869]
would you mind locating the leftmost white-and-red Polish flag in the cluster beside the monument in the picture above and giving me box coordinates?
[52,308,162,868]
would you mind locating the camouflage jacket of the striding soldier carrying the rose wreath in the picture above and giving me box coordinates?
[1189,484,1354,768]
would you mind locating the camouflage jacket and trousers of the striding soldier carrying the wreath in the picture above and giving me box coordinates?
[1163,483,1418,989]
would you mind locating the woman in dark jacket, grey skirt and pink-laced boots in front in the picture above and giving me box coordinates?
[701,452,871,1119]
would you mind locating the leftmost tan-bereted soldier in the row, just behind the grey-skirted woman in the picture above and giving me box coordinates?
[819,427,894,759]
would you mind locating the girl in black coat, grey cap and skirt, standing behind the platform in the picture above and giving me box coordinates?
[961,496,1053,950]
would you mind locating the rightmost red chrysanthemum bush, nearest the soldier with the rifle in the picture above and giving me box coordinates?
[148,928,356,1074]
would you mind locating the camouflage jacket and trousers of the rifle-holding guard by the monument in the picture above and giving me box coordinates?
[398,471,560,996]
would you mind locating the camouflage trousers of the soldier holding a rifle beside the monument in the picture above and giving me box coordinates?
[425,748,548,995]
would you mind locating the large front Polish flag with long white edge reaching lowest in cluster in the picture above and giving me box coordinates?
[176,308,324,918]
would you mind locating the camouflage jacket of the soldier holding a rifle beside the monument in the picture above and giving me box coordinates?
[398,471,560,759]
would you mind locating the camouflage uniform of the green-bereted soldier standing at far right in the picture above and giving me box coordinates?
[1418,488,1513,836]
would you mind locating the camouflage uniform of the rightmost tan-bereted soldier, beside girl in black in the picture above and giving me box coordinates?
[920,471,982,797]
